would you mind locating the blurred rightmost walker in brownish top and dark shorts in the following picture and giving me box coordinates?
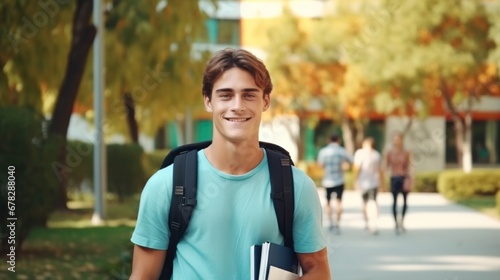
[384,132,413,234]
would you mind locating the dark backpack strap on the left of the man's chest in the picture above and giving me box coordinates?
[160,149,198,279]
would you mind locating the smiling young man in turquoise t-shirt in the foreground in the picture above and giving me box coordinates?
[130,49,330,280]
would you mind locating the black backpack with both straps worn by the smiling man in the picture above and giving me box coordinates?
[160,141,295,279]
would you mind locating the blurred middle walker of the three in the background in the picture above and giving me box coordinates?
[354,137,384,235]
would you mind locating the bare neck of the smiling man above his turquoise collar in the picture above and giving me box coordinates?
[205,139,264,175]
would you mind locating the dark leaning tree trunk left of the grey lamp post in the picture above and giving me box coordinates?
[49,0,96,209]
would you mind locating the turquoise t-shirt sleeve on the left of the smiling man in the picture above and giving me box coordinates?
[131,166,172,250]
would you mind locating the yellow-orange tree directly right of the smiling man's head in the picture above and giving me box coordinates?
[266,5,373,157]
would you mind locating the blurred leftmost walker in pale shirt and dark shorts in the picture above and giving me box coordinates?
[318,134,352,234]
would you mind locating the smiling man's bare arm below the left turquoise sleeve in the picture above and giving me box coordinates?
[130,245,167,280]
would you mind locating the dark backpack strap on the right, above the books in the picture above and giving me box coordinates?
[266,149,295,249]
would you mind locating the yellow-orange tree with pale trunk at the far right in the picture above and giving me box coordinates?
[354,0,496,171]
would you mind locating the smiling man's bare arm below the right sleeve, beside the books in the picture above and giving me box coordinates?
[297,247,331,280]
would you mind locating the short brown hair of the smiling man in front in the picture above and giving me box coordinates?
[201,48,273,99]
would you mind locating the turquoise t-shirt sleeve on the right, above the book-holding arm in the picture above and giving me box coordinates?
[293,168,326,253]
